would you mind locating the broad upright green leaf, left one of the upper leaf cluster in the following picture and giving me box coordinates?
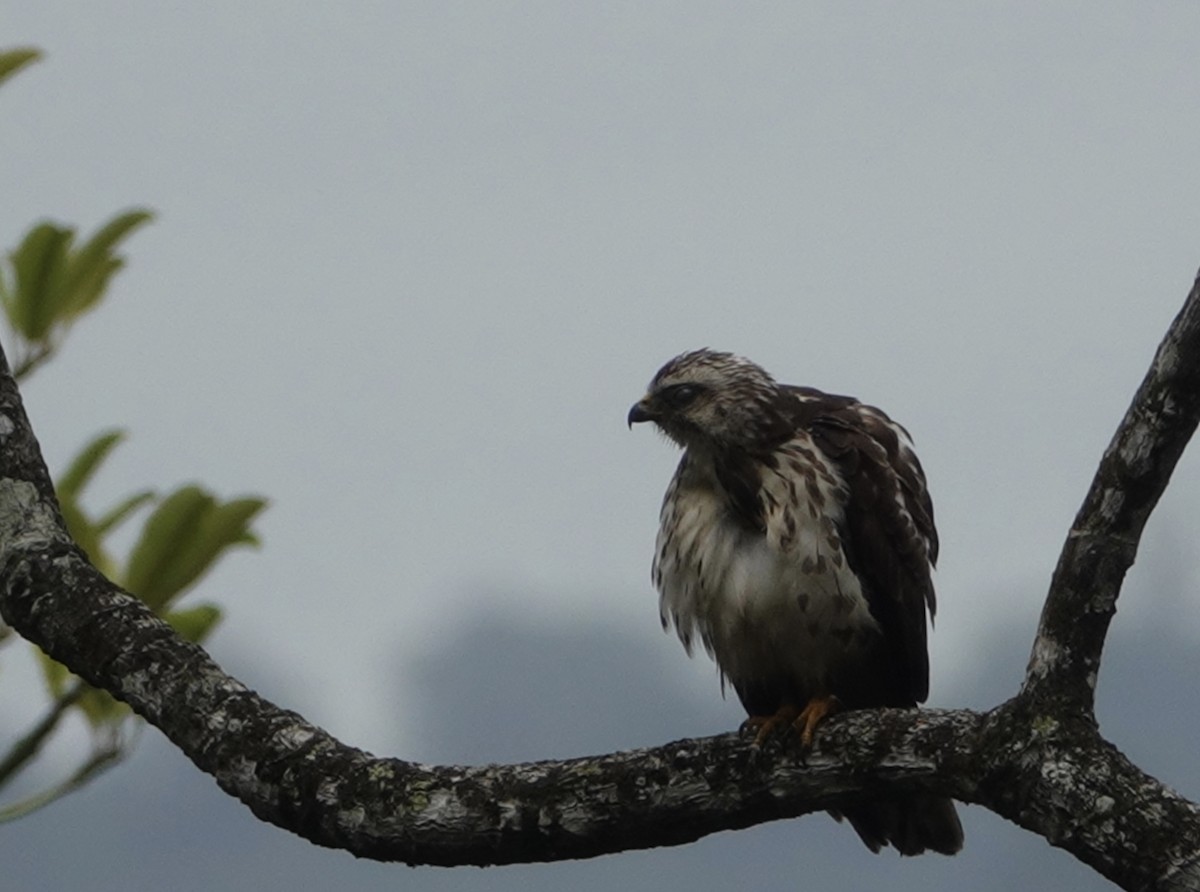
[5,222,74,341]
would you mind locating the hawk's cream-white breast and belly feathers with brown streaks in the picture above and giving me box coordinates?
[653,443,878,694]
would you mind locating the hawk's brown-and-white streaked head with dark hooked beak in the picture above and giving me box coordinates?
[629,348,784,449]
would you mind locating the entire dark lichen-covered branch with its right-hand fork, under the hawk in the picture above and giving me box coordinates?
[0,272,1200,890]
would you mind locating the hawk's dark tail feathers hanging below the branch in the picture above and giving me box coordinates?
[829,796,962,855]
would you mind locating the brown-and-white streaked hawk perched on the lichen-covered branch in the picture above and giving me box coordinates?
[629,349,962,855]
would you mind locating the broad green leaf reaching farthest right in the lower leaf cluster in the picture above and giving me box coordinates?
[125,486,266,611]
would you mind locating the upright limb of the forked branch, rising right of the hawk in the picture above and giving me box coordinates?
[1022,268,1200,716]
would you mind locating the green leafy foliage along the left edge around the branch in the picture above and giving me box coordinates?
[0,42,266,822]
